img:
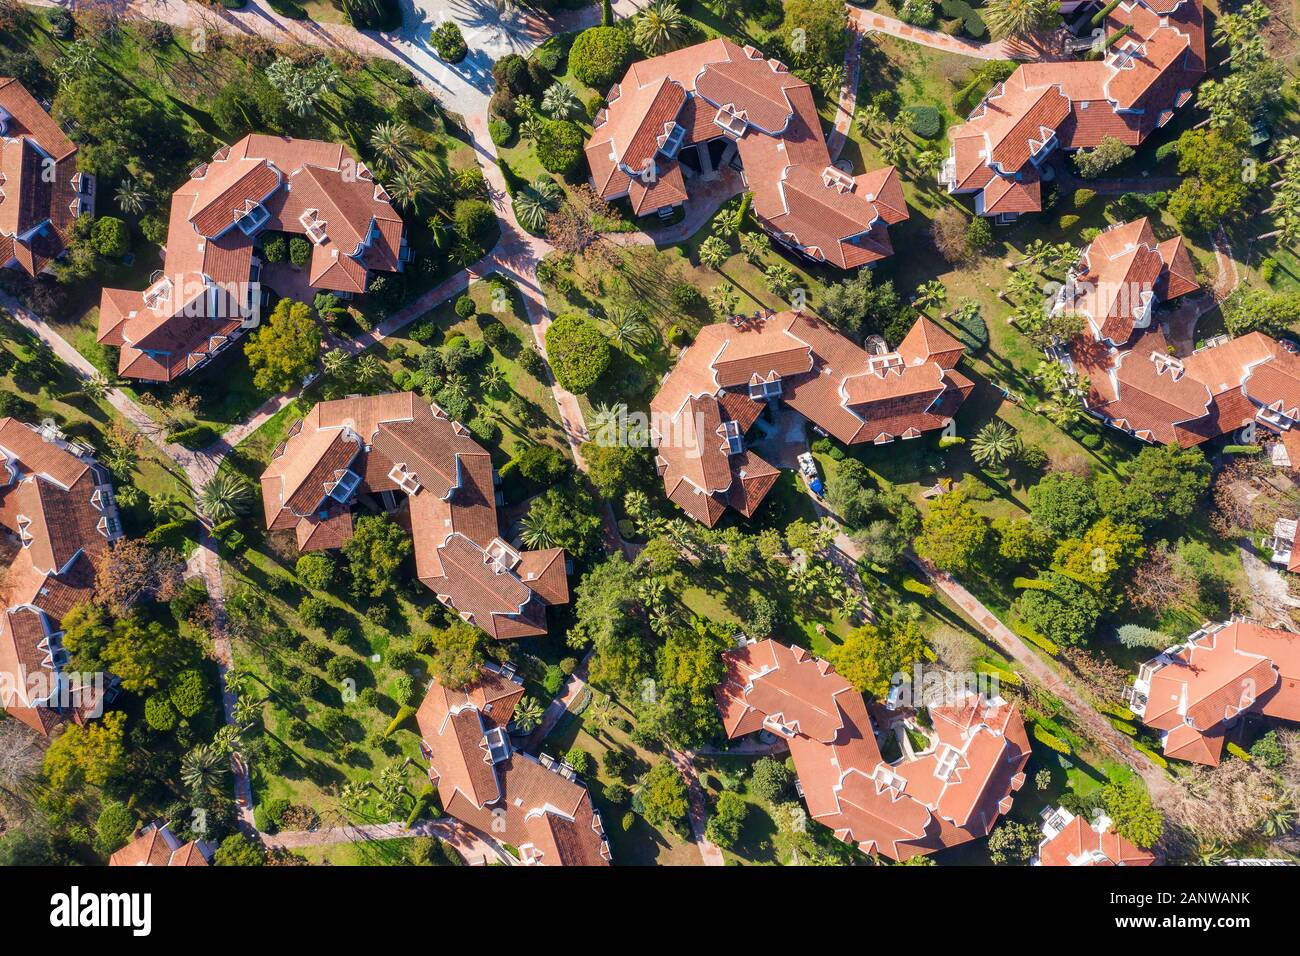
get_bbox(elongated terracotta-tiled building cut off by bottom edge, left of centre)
[415,665,611,866]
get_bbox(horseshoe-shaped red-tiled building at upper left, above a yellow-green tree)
[98,134,410,381]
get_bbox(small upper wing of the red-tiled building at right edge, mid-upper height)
[1053,217,1200,349]
